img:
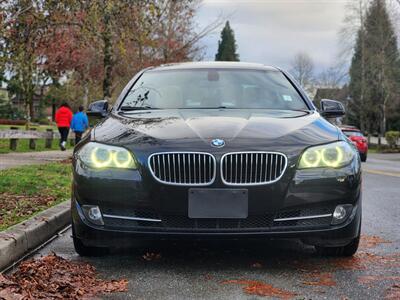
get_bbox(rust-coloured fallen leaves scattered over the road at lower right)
[217,235,400,299]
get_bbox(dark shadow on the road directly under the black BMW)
[96,240,319,272]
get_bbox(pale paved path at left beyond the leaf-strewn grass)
[0,149,72,170]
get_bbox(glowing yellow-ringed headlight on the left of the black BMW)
[77,142,137,169]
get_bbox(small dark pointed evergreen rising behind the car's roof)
[215,21,239,61]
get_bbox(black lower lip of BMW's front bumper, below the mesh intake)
[72,199,361,247]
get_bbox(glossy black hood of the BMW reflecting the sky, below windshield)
[92,109,338,150]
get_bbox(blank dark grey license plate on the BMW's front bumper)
[188,189,248,219]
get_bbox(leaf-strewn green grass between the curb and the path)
[0,163,71,231]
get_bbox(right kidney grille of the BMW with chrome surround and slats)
[220,151,288,186]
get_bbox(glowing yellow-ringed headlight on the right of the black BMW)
[299,142,355,169]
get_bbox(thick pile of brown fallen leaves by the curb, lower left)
[0,253,128,299]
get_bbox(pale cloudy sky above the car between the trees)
[197,0,354,72]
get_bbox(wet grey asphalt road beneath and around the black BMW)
[24,154,400,299]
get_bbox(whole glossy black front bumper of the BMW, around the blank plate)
[72,155,361,246]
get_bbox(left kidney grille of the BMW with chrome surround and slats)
[147,151,217,186]
